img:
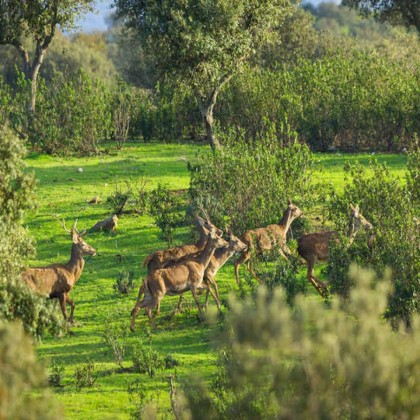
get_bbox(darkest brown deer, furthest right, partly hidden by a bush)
[297,204,373,297]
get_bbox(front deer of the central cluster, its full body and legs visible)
[130,228,228,331]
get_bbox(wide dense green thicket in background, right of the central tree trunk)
[215,52,420,151]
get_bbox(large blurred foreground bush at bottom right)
[184,270,420,419]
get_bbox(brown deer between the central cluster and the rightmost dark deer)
[235,199,303,285]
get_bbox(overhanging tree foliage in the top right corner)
[343,0,420,34]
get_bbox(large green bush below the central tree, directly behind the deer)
[189,132,313,234]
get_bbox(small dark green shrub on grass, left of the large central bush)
[150,184,184,244]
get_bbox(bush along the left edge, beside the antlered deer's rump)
[0,126,62,338]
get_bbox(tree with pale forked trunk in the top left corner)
[0,0,93,120]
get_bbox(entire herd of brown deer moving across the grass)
[22,200,372,331]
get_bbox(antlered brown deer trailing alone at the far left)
[22,220,96,323]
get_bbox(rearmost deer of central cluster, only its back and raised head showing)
[143,210,223,274]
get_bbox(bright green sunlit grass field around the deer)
[23,144,406,419]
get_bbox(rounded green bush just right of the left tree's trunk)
[31,71,111,155]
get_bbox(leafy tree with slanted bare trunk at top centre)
[115,0,295,150]
